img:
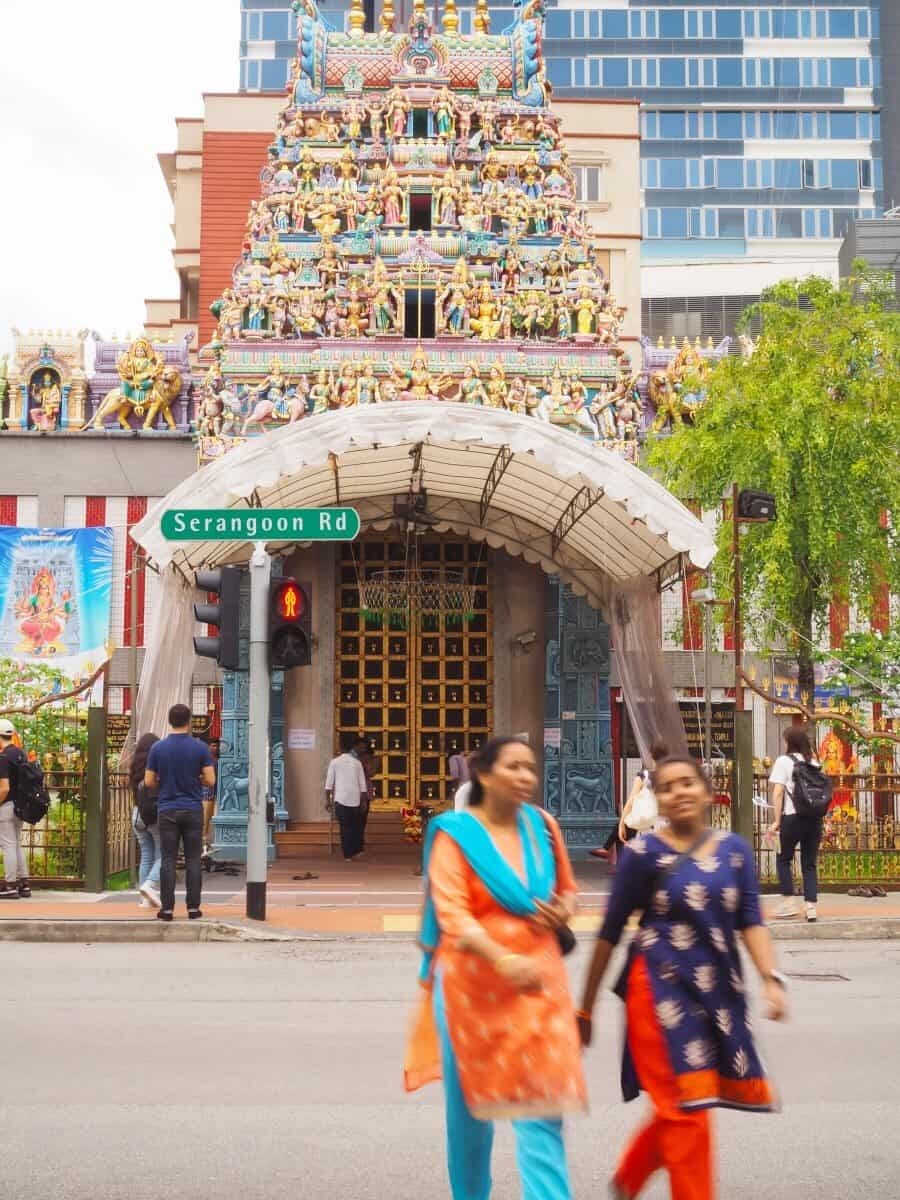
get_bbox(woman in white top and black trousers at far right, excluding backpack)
[768,725,823,922]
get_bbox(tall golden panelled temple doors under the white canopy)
[335,534,493,811]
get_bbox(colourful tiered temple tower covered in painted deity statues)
[198,0,642,461]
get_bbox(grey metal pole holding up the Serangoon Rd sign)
[247,541,271,920]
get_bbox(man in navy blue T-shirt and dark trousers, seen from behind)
[150,704,216,920]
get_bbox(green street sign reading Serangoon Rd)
[160,509,360,541]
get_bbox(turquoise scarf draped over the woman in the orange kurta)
[419,804,557,982]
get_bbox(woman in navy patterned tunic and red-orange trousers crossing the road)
[578,757,786,1200]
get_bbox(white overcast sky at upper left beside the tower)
[0,0,240,353]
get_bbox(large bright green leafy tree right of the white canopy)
[646,263,900,704]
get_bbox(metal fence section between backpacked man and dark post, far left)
[22,770,85,884]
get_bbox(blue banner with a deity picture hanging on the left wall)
[0,526,113,678]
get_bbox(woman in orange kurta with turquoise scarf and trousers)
[406,738,586,1200]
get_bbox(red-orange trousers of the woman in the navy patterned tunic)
[614,956,715,1200]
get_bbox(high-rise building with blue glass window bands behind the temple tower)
[241,0,900,338]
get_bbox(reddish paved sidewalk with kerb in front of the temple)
[0,859,900,941]
